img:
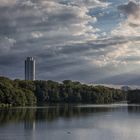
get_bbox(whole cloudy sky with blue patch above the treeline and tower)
[0,0,140,85]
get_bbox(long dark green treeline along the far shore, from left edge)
[0,77,126,106]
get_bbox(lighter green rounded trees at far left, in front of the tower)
[0,77,36,106]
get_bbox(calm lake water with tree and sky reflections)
[0,104,140,140]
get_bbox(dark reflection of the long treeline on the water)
[0,104,111,128]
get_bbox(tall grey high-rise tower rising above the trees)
[25,57,35,81]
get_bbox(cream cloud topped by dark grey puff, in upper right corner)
[111,1,140,38]
